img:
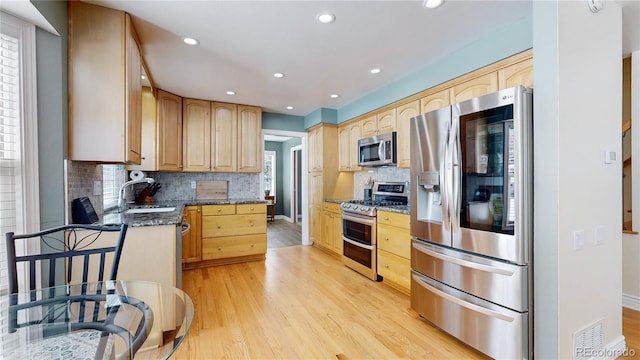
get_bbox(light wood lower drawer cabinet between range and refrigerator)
[377,210,411,294]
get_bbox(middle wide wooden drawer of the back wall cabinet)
[202,214,267,238]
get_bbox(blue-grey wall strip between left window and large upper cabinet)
[33,1,68,228]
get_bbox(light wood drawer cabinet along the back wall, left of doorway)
[183,204,267,269]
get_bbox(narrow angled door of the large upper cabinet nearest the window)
[125,15,142,164]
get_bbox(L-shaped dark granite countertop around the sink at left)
[98,199,267,227]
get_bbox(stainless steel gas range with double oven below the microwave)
[340,182,408,281]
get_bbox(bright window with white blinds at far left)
[0,13,40,294]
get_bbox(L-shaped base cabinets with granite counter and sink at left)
[94,199,266,288]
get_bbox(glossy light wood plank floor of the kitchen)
[174,246,640,359]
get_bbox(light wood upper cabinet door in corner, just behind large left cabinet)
[127,86,158,171]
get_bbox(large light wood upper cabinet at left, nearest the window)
[69,1,142,164]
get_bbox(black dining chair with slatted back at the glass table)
[6,224,153,358]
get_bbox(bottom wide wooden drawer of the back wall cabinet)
[202,234,267,260]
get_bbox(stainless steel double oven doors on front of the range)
[342,212,379,281]
